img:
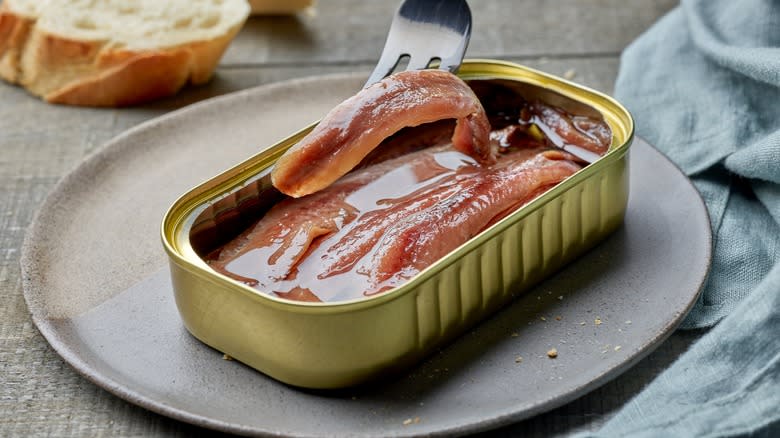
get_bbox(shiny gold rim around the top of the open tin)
[160,59,634,314]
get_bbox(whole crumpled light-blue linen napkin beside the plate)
[576,0,780,437]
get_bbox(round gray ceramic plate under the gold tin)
[22,76,711,436]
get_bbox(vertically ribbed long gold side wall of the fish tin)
[415,157,628,360]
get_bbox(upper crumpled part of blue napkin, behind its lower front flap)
[615,0,780,328]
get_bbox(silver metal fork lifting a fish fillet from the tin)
[364,0,471,88]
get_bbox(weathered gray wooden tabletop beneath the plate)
[0,0,697,436]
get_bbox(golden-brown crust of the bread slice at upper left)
[0,1,244,107]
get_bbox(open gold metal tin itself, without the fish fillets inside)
[162,60,633,388]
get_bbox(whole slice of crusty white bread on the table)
[0,0,249,106]
